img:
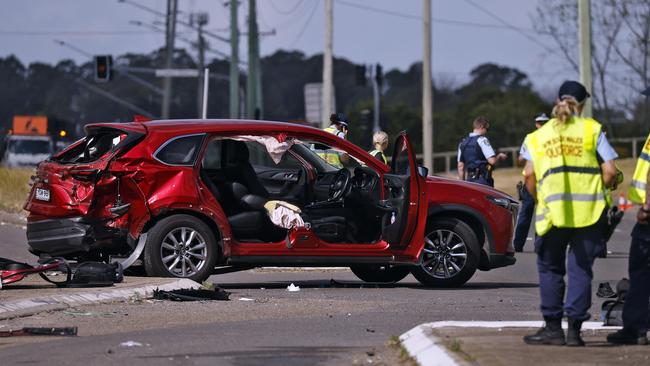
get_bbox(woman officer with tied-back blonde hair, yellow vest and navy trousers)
[524,81,618,346]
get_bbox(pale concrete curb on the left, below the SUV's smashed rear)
[0,278,201,320]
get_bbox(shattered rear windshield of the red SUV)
[52,129,140,163]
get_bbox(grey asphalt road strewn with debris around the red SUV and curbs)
[0,214,633,366]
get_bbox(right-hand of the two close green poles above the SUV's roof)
[246,0,261,118]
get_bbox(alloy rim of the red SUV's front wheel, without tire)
[421,229,467,279]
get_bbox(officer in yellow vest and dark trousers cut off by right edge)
[607,88,650,344]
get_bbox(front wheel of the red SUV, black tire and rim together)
[411,218,481,287]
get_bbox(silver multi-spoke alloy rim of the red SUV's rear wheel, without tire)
[160,226,208,277]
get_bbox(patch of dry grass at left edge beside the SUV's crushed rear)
[0,167,33,213]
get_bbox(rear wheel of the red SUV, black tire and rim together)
[144,214,219,282]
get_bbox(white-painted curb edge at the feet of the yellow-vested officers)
[399,321,621,366]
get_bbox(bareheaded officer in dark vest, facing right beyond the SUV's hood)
[458,117,507,187]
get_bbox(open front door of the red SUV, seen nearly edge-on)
[382,132,424,248]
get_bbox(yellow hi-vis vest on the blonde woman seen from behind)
[528,117,606,235]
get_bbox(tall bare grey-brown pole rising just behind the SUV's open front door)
[422,0,433,173]
